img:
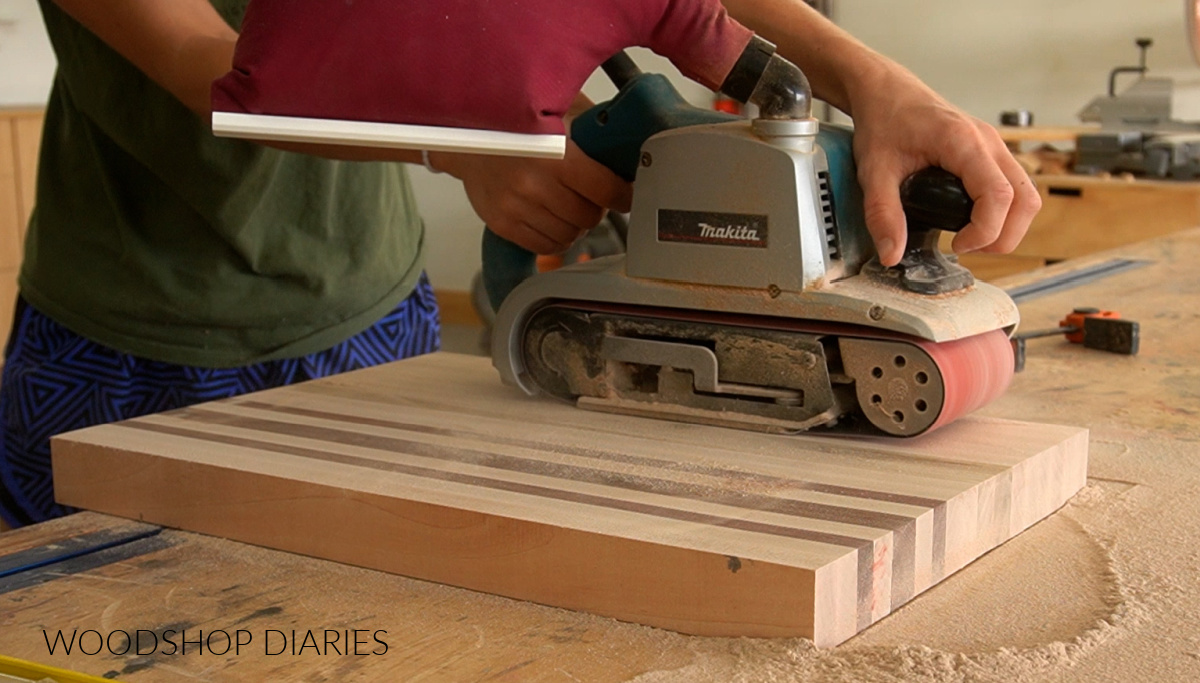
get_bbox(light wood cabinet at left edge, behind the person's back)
[0,109,42,345]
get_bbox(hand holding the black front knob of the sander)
[850,65,1042,265]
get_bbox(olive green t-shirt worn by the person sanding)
[19,0,424,367]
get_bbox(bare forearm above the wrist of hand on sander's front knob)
[721,0,898,114]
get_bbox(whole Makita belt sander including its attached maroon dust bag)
[212,0,1018,436]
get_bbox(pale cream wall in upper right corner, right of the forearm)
[836,0,1200,125]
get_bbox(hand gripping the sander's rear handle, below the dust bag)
[430,142,634,253]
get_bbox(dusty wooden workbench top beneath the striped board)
[0,230,1200,681]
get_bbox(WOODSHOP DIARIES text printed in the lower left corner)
[42,629,388,657]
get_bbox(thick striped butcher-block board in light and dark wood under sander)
[53,353,1087,646]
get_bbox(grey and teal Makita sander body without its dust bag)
[484,38,1018,436]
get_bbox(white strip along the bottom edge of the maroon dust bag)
[212,112,566,158]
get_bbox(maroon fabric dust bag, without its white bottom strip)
[212,0,752,133]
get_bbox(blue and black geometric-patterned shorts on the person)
[0,275,440,527]
